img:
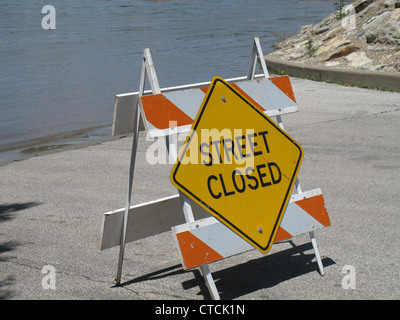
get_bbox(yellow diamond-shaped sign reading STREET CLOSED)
[170,77,303,253]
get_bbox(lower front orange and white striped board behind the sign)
[172,189,330,269]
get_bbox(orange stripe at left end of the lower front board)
[176,231,224,269]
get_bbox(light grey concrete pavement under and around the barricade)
[0,78,400,300]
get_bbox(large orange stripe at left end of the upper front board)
[142,94,193,129]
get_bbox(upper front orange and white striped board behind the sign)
[139,76,298,137]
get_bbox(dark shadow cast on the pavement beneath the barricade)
[121,241,335,300]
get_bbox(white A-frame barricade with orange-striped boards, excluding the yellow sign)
[101,37,330,299]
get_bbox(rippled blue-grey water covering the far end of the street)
[0,0,344,162]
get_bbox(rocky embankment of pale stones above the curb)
[267,0,400,72]
